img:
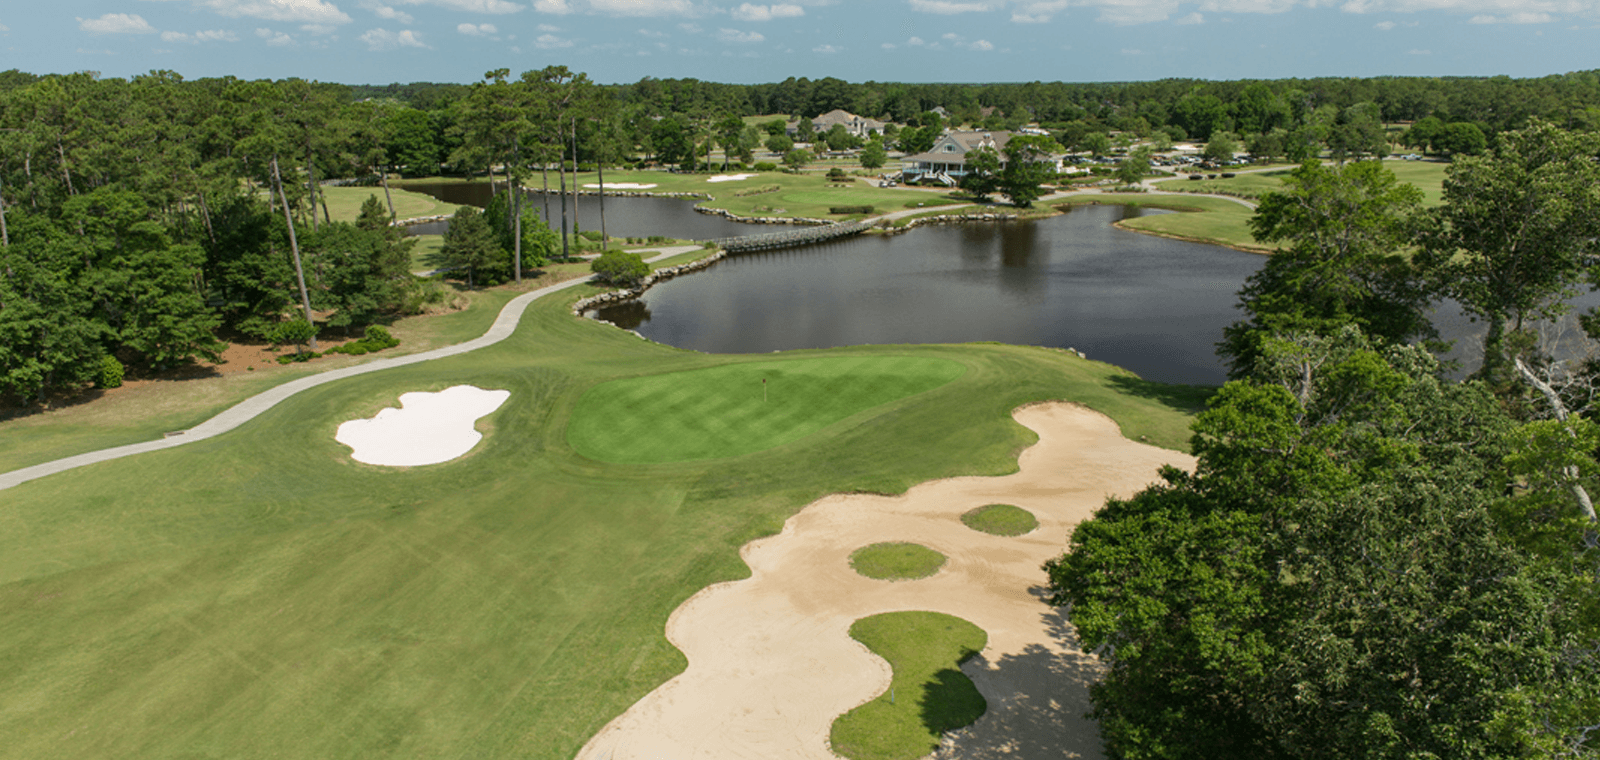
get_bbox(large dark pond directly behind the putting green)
[598,206,1266,384]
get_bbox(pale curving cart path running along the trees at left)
[0,245,699,491]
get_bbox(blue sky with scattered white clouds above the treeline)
[0,0,1600,83]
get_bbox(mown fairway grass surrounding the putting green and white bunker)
[0,265,1203,758]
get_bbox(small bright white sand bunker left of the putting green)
[334,386,510,467]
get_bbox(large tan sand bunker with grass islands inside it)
[578,403,1194,760]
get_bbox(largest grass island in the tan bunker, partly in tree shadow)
[829,613,989,760]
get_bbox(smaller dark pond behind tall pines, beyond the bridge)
[396,182,752,240]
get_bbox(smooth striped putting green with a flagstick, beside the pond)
[566,357,966,464]
